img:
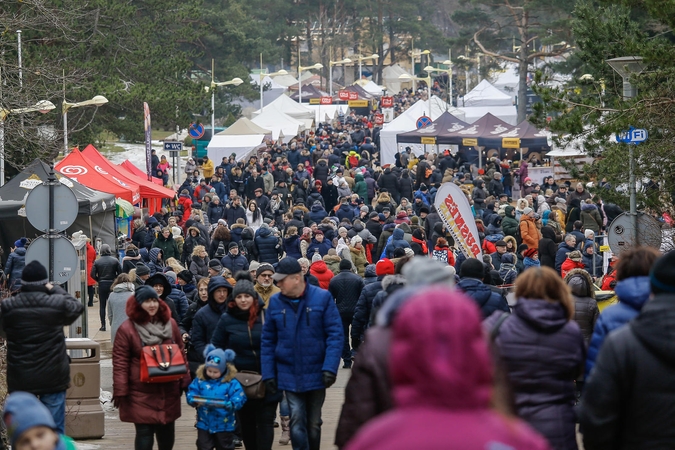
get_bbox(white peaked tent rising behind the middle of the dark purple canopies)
[458,80,518,125]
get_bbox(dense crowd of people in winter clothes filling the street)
[0,108,675,450]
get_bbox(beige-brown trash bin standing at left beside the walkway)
[66,338,105,439]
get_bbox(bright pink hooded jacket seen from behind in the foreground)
[346,287,550,450]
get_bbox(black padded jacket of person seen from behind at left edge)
[0,285,84,395]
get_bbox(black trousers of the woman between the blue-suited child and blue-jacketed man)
[237,399,277,450]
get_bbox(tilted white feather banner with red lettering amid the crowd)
[434,182,482,259]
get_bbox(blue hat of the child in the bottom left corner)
[3,391,56,447]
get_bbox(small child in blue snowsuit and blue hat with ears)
[187,344,246,450]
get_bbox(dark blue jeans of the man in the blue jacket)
[286,389,326,450]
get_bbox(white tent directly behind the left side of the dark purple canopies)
[380,95,464,165]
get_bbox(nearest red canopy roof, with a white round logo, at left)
[54,149,141,204]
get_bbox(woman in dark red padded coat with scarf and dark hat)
[113,286,190,450]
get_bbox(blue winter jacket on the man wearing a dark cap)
[261,285,344,393]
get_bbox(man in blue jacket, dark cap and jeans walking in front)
[261,257,343,450]
